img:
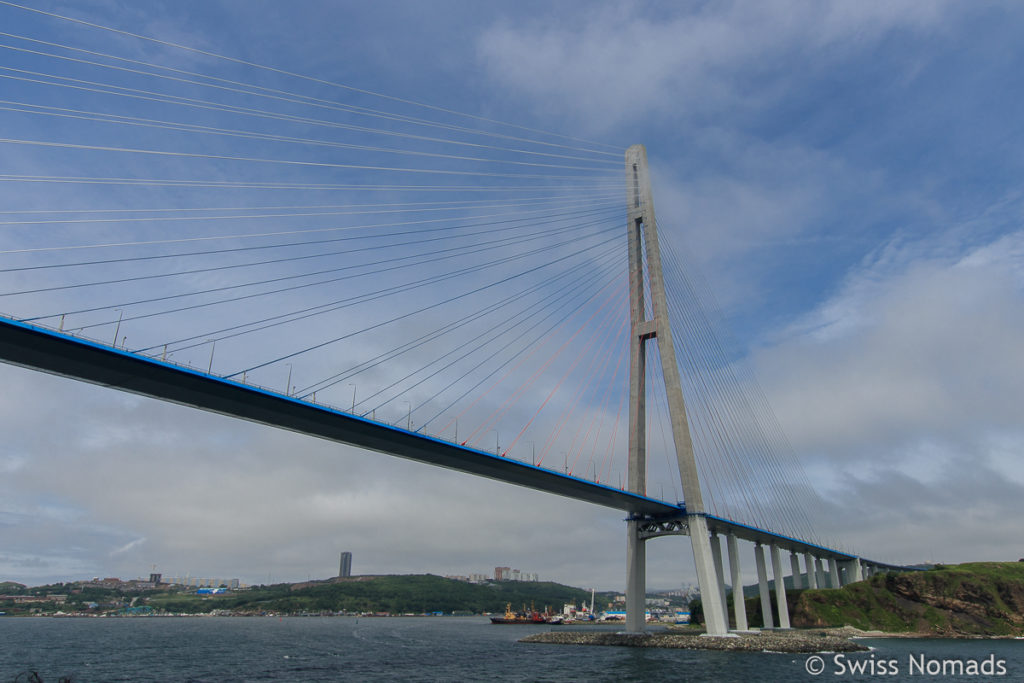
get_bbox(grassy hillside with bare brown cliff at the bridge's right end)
[792,562,1024,636]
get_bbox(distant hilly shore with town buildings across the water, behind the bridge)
[0,552,696,620]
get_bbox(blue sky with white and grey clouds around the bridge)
[0,0,1024,590]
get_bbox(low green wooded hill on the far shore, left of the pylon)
[147,574,610,614]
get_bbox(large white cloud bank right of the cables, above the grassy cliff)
[755,228,1024,561]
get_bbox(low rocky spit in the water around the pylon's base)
[519,629,869,653]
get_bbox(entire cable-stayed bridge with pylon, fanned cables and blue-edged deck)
[0,3,913,634]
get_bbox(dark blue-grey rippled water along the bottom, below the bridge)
[0,617,1024,683]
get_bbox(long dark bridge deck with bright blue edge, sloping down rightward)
[0,317,898,568]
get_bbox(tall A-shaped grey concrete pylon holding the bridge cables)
[626,144,729,636]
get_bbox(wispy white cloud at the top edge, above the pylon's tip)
[477,2,949,134]
